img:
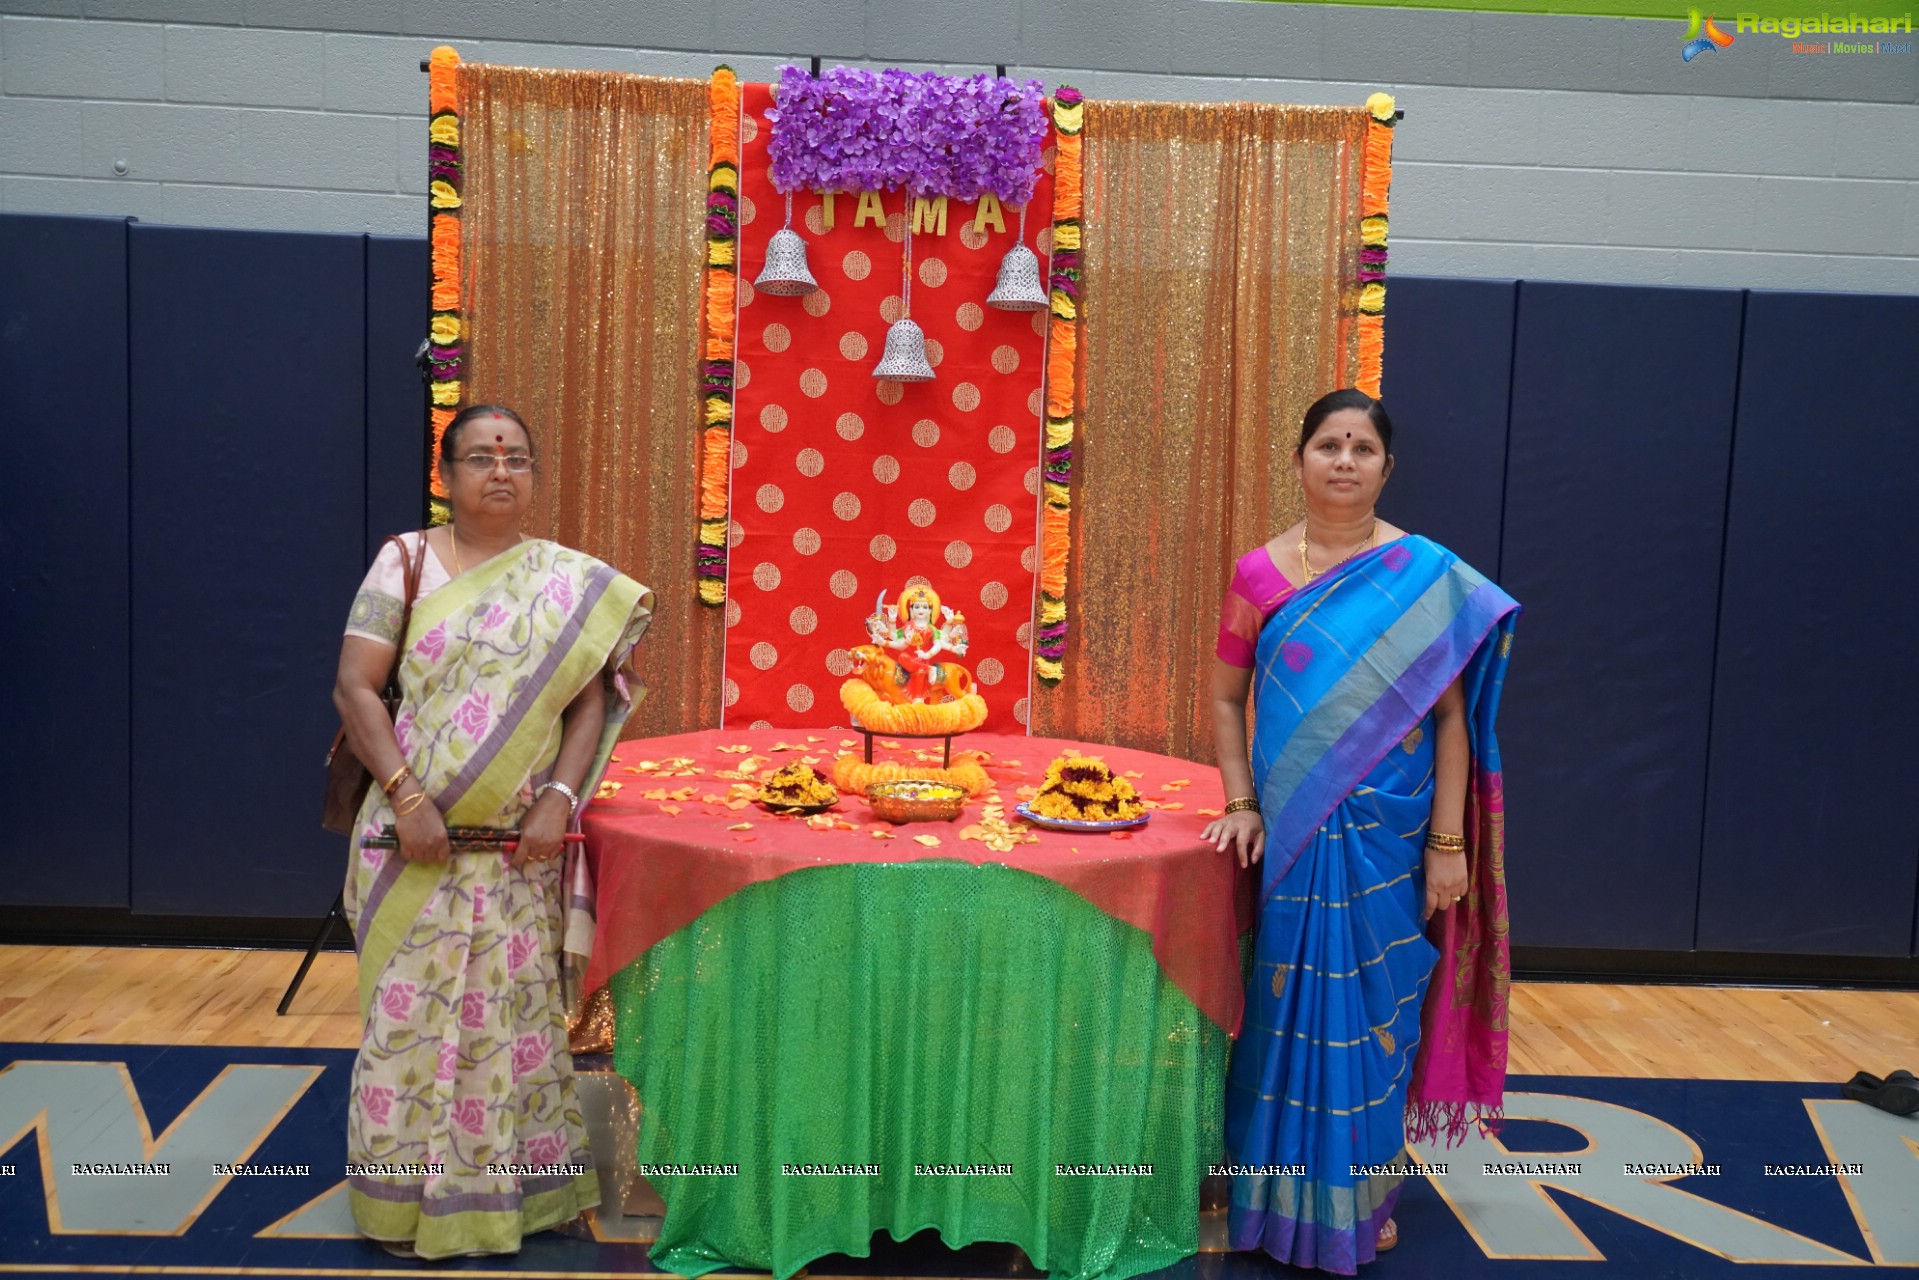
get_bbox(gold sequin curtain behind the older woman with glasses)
[459,63,725,737]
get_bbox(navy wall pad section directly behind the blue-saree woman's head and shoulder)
[1380,278,1520,581]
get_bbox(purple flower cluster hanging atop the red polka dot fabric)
[766,67,1046,207]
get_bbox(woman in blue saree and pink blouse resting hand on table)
[1205,390,1518,1274]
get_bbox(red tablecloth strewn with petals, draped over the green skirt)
[583,729,1257,1034]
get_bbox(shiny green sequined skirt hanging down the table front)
[612,862,1228,1280]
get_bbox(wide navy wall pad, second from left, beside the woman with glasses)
[129,226,367,917]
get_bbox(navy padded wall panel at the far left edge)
[0,213,129,908]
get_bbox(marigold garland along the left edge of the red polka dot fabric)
[693,65,741,604]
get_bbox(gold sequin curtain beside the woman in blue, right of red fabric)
[1032,100,1366,762]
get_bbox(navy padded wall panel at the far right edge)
[1698,294,1919,956]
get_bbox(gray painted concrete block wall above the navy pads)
[0,0,1919,292]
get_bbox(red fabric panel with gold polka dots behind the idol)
[723,84,1054,733]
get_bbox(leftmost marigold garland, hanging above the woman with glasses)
[426,44,466,524]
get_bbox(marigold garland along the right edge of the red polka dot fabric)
[1032,84,1086,685]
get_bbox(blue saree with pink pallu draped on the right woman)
[1226,537,1518,1274]
